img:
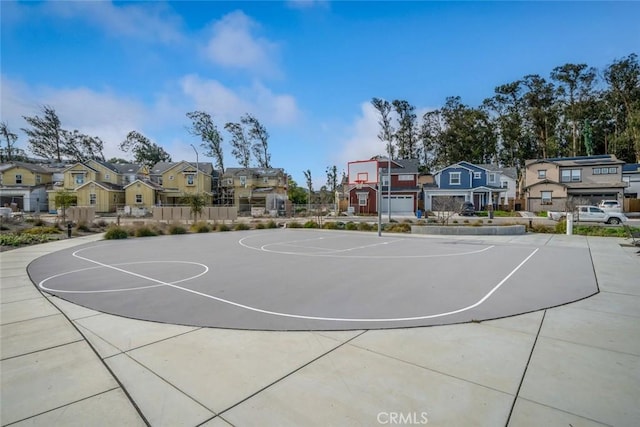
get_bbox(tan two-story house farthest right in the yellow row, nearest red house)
[220,168,288,215]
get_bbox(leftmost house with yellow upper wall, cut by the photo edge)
[0,161,59,212]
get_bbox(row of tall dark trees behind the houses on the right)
[371,53,640,171]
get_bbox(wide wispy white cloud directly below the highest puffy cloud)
[180,74,300,126]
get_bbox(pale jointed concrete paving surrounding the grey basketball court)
[0,234,640,426]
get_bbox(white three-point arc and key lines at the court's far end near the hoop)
[238,235,495,259]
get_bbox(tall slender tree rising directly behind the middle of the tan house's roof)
[551,64,596,156]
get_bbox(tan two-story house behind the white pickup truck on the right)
[523,154,627,212]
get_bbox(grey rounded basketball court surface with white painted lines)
[28,229,598,330]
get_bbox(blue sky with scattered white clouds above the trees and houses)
[0,1,640,189]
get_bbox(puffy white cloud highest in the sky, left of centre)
[204,10,278,75]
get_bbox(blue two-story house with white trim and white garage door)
[424,162,516,211]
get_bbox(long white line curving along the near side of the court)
[38,242,540,322]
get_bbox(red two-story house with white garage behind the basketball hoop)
[348,157,420,215]
